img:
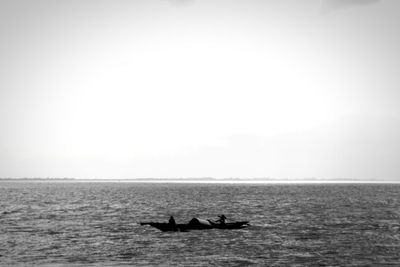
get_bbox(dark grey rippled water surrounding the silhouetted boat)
[0,182,400,266]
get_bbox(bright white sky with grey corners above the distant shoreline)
[0,0,400,180]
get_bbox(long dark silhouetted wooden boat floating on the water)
[140,218,249,232]
